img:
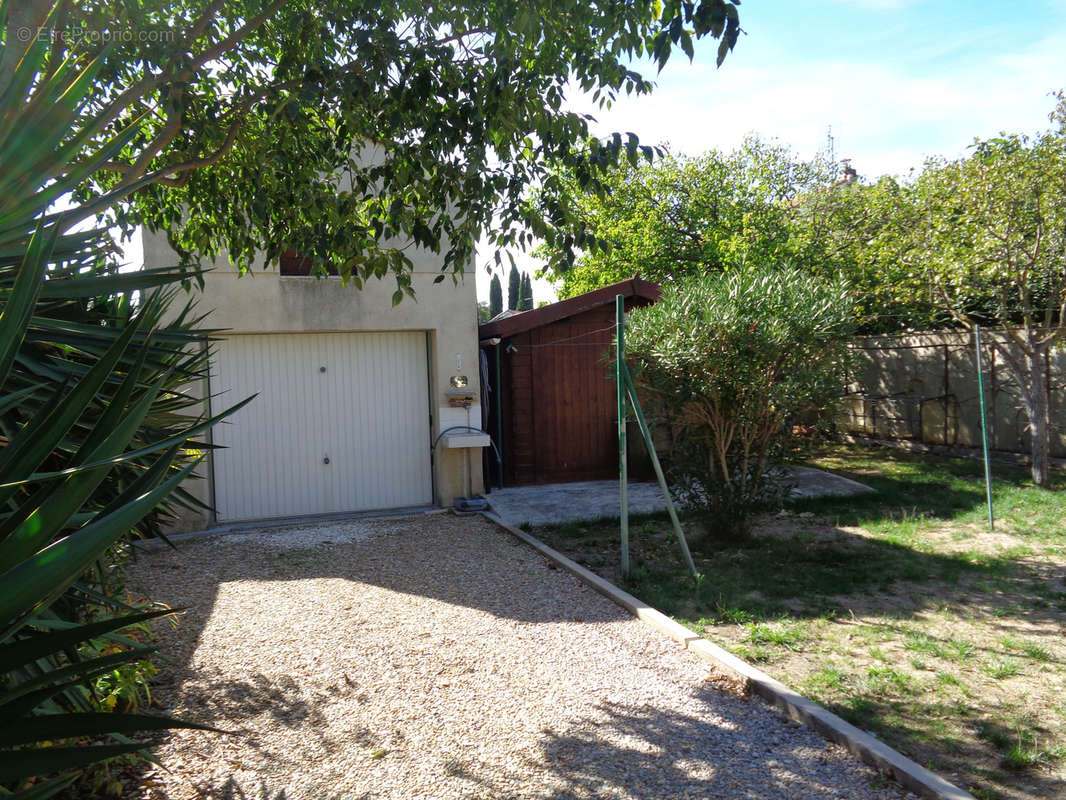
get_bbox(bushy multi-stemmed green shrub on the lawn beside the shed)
[626,269,854,539]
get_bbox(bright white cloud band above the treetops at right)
[579,30,1066,174]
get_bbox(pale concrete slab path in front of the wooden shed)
[488,466,874,526]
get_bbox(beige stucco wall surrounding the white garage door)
[143,231,484,530]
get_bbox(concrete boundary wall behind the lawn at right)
[838,330,1066,458]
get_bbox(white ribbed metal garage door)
[211,332,433,521]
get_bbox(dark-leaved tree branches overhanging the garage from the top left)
[0,0,740,300]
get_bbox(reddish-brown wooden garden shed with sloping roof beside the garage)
[479,278,660,486]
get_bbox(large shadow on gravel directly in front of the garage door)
[131,515,630,626]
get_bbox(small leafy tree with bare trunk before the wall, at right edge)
[900,96,1066,486]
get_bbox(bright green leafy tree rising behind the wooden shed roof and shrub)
[539,137,834,297]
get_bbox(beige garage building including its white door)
[144,231,487,530]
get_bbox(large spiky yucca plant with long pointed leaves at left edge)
[0,12,245,800]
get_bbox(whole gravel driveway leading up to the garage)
[130,514,909,800]
